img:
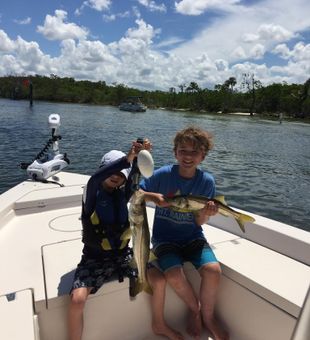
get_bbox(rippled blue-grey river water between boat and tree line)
[0,99,310,231]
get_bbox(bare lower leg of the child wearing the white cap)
[68,287,92,340]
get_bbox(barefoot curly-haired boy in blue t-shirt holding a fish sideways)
[140,127,228,340]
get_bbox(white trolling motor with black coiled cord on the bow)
[20,114,70,182]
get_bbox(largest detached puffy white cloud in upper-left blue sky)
[37,9,88,40]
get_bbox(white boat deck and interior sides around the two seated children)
[0,172,310,340]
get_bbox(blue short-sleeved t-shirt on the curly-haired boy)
[140,165,215,244]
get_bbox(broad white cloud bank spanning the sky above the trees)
[0,0,310,90]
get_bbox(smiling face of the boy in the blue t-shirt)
[175,142,206,169]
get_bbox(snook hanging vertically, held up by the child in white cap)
[129,190,152,297]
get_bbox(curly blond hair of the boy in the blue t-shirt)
[173,126,213,154]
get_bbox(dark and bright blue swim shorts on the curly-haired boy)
[148,238,218,272]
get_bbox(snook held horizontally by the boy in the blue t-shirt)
[165,195,255,232]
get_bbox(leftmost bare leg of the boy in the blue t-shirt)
[147,267,184,340]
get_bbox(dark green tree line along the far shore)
[0,74,310,119]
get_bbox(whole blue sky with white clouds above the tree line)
[0,0,310,91]
